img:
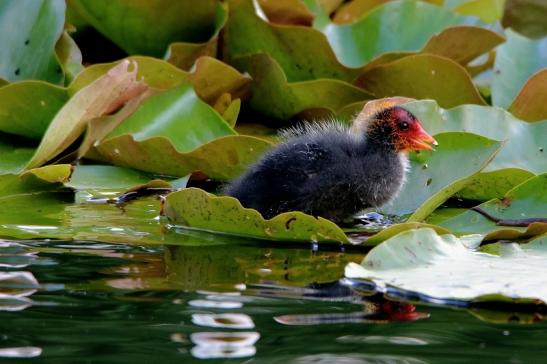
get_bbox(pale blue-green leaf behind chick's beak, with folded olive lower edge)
[405,101,547,200]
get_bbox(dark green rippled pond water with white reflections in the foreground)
[0,200,547,364]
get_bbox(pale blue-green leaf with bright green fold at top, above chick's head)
[322,0,479,67]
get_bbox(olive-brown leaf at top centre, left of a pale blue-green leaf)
[223,0,359,82]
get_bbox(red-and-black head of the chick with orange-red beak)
[352,98,437,152]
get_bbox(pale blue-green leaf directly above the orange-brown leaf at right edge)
[492,29,547,108]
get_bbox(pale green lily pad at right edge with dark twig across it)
[441,173,547,239]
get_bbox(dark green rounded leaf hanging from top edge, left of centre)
[69,0,217,57]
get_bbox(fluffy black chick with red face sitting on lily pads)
[223,98,437,224]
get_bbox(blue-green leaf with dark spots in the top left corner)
[0,0,65,83]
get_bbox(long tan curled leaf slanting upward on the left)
[26,61,146,169]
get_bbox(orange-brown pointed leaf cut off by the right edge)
[508,69,547,121]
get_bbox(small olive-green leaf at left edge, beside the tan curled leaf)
[0,81,69,139]
